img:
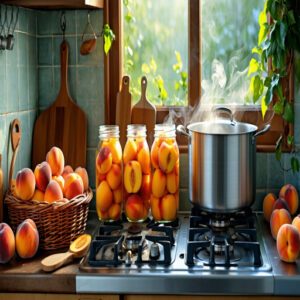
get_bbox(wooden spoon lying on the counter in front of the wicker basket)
[41,234,92,272]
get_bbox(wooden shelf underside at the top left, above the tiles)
[1,0,105,9]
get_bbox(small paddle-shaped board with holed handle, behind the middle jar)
[131,76,156,147]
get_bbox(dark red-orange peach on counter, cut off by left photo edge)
[0,223,15,264]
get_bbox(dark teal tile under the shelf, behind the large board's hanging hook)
[37,10,76,35]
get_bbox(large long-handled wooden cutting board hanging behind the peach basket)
[32,41,87,168]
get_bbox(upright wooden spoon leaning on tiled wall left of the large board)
[8,119,22,189]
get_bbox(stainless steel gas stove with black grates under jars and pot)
[76,210,273,294]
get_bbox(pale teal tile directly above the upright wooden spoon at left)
[5,66,19,112]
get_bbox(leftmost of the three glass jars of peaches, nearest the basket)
[96,125,123,221]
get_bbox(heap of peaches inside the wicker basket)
[12,147,89,203]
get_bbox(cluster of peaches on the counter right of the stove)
[263,184,300,262]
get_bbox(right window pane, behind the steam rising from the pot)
[201,0,264,104]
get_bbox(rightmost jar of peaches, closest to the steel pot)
[150,124,179,222]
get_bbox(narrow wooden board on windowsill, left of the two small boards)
[116,76,131,148]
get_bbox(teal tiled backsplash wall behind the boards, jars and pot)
[0,5,300,210]
